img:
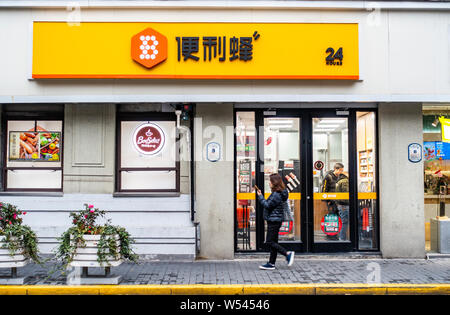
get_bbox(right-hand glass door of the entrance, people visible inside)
[309,114,353,252]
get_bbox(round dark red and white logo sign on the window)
[133,123,166,155]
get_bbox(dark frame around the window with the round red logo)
[114,112,181,193]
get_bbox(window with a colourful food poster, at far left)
[3,119,63,191]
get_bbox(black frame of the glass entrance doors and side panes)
[233,107,380,253]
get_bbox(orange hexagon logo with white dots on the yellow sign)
[131,27,167,69]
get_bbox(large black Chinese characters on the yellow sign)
[176,31,260,62]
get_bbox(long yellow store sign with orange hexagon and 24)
[32,22,359,80]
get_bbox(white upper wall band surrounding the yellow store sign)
[0,8,450,103]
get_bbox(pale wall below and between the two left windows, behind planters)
[0,104,196,260]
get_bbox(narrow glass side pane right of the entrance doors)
[356,112,378,250]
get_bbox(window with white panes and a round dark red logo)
[117,115,180,192]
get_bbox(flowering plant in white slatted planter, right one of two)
[56,204,138,283]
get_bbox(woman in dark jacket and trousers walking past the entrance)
[256,173,295,270]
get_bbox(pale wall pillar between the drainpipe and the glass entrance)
[194,104,234,259]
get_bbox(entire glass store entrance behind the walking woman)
[235,109,379,252]
